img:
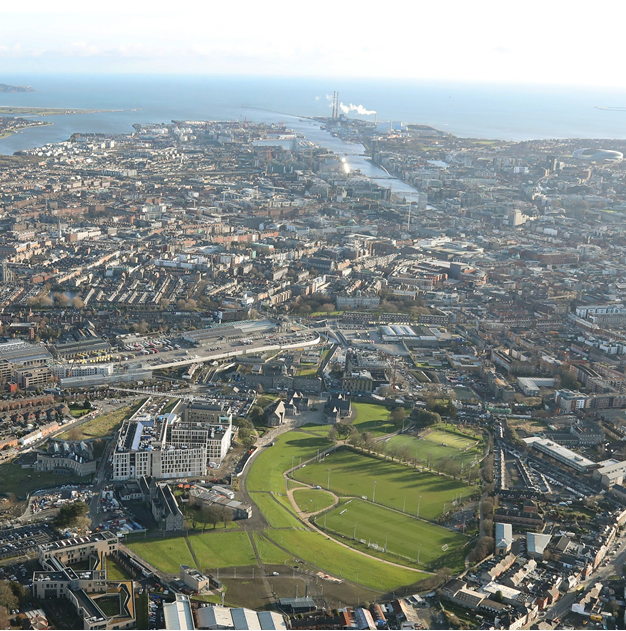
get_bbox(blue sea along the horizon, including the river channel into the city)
[0,74,626,196]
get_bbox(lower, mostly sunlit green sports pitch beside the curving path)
[316,500,467,569]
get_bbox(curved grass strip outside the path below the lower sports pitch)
[265,530,425,592]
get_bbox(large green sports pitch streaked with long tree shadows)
[294,449,474,519]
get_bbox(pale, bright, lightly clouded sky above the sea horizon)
[0,0,626,89]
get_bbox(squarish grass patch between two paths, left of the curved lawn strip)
[189,532,256,570]
